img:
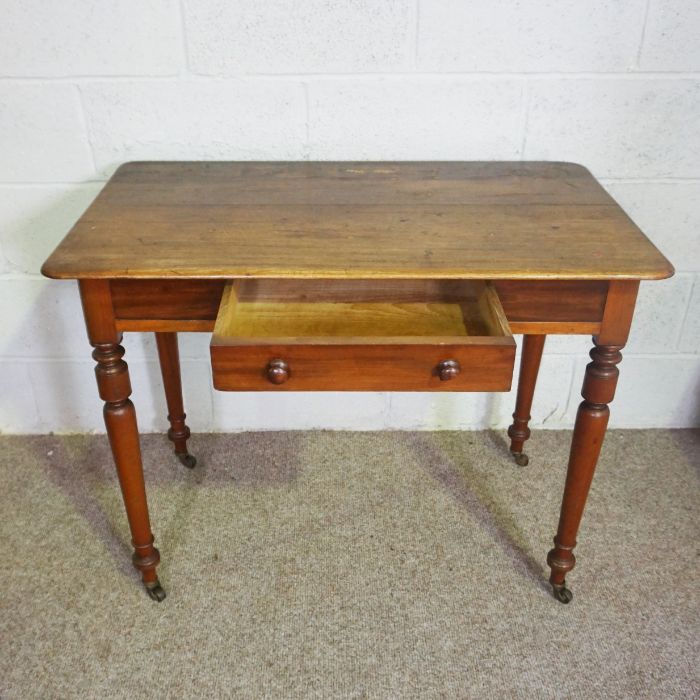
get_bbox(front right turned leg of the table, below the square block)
[547,339,623,603]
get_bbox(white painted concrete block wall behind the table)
[0,0,700,432]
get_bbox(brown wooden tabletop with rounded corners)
[42,161,673,279]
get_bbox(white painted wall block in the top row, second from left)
[184,0,415,76]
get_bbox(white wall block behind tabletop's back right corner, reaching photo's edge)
[523,77,700,179]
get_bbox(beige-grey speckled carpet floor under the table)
[0,431,700,700]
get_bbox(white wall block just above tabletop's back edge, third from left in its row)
[309,76,523,160]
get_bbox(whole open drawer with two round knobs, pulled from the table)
[211,280,515,391]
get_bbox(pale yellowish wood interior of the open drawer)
[212,280,514,345]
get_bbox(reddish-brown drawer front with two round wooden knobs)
[211,342,515,391]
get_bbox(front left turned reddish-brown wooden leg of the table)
[80,280,160,590]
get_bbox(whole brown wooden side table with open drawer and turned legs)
[42,162,673,603]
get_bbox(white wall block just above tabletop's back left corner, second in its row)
[81,78,306,177]
